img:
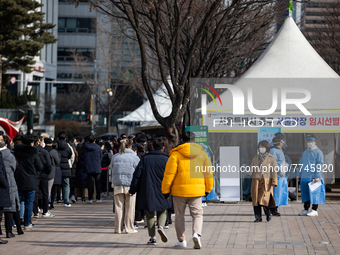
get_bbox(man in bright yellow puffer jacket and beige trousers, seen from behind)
[162,132,214,249]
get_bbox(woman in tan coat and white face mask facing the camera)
[247,141,277,222]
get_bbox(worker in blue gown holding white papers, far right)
[297,135,325,216]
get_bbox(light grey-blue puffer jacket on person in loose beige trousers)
[110,149,139,186]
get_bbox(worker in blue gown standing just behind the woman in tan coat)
[269,133,288,216]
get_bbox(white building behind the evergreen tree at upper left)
[6,0,58,124]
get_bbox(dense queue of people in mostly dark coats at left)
[0,131,117,244]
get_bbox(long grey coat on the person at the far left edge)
[1,148,20,212]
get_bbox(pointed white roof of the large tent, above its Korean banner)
[207,17,340,111]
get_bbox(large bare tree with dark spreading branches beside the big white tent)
[70,0,288,142]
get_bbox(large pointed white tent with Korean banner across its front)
[202,17,340,200]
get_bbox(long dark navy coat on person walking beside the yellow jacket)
[130,150,169,211]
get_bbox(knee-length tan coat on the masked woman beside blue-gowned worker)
[250,154,277,208]
